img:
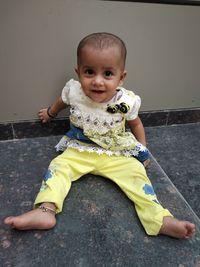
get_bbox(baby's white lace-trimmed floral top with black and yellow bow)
[56,79,144,156]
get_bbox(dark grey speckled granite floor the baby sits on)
[0,124,200,267]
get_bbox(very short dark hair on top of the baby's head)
[77,32,127,67]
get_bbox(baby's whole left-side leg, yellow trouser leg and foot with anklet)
[4,149,96,230]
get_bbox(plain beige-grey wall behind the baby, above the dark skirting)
[0,0,200,122]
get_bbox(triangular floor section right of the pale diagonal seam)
[146,123,200,218]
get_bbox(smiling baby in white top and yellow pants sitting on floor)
[4,33,195,238]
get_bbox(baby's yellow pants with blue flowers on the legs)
[35,148,172,235]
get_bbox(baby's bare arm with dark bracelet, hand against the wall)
[38,97,67,123]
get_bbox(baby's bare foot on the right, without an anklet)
[159,216,195,238]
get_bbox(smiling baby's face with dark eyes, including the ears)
[76,45,126,103]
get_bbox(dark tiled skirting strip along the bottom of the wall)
[0,108,200,140]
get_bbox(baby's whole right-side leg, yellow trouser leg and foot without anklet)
[99,156,195,238]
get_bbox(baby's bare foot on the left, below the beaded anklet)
[4,208,56,230]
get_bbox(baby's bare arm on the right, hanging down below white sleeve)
[128,117,146,146]
